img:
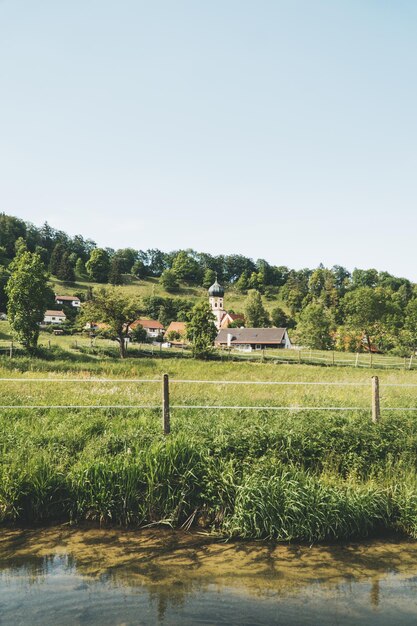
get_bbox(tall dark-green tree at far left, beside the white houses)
[5,247,54,353]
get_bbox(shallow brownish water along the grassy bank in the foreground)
[0,526,417,626]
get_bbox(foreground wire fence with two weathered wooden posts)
[0,374,417,434]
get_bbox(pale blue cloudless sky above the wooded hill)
[0,0,417,281]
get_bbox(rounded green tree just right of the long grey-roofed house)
[297,302,333,350]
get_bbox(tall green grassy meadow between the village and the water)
[0,346,417,542]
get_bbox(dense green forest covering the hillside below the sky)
[0,213,417,354]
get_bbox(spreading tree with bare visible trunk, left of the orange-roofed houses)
[81,287,140,359]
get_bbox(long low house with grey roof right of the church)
[214,328,291,352]
